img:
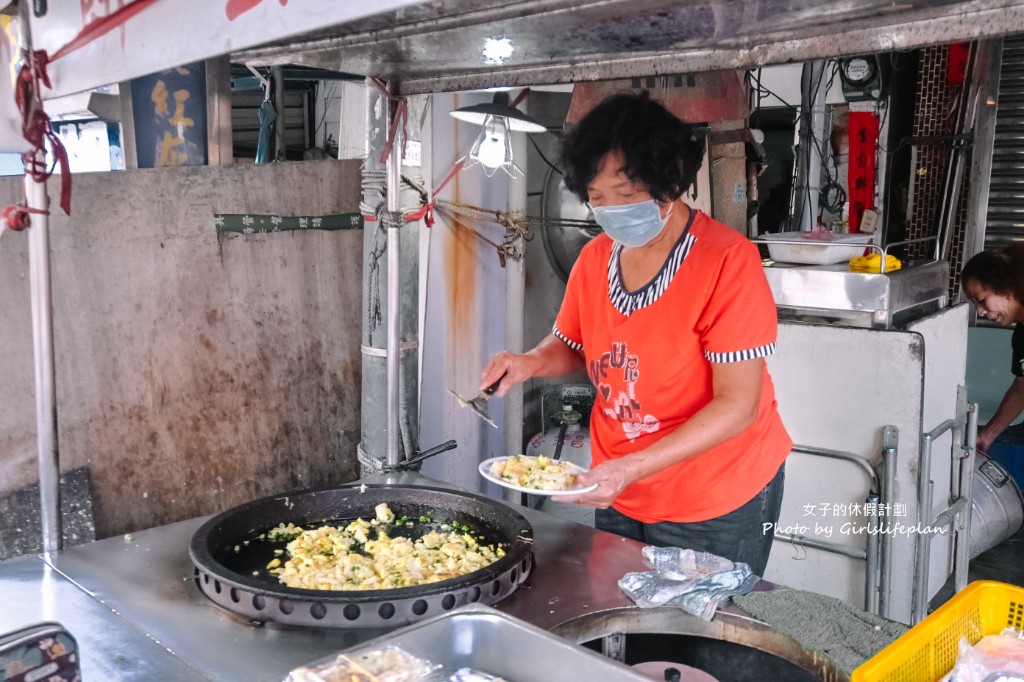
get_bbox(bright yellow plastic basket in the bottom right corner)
[853,581,1024,682]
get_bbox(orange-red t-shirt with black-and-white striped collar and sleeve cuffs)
[553,210,793,523]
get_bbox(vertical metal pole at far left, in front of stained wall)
[25,159,63,553]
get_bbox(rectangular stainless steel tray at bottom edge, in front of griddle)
[288,604,650,682]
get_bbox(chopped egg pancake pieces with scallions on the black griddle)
[267,504,505,590]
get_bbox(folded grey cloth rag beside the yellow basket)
[733,588,907,673]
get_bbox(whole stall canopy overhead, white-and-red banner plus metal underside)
[32,0,1024,97]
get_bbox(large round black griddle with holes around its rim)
[189,484,534,628]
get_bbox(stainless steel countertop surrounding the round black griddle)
[0,474,648,682]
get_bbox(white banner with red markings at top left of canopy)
[31,0,422,99]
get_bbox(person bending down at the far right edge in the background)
[961,244,1024,453]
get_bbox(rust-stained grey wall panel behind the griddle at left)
[0,161,362,538]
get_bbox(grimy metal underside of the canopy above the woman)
[234,0,1024,94]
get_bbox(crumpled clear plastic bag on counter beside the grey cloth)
[618,546,758,621]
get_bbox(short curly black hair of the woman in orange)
[560,90,705,202]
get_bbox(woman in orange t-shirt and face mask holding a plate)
[481,93,793,576]
